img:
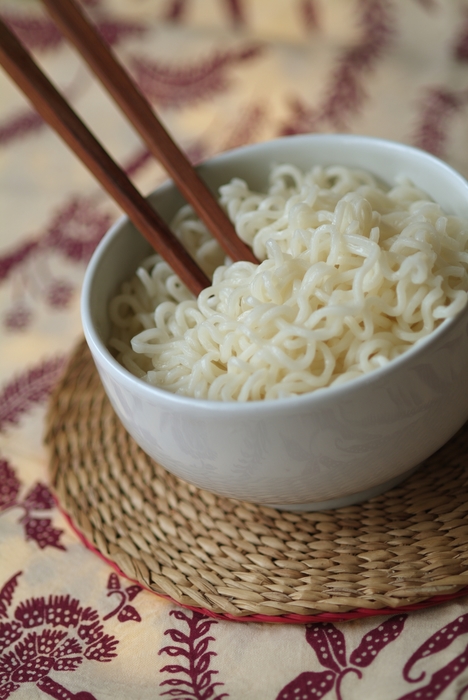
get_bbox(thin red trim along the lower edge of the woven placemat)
[54,495,468,625]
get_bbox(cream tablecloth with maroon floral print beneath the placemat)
[0,0,468,700]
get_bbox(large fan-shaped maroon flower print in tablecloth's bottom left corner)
[0,572,118,700]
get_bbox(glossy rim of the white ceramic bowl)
[80,134,468,414]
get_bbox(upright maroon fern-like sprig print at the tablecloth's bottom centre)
[159,610,228,700]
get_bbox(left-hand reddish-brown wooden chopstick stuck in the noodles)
[0,20,211,295]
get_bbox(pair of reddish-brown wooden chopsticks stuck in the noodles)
[0,0,258,295]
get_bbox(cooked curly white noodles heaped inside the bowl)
[109,165,468,401]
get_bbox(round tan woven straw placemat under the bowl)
[46,341,468,622]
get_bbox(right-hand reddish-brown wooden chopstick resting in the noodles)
[43,0,258,263]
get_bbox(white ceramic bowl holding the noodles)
[82,135,468,510]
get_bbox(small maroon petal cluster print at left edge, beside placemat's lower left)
[0,458,65,549]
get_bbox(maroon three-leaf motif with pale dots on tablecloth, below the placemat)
[276,615,408,700]
